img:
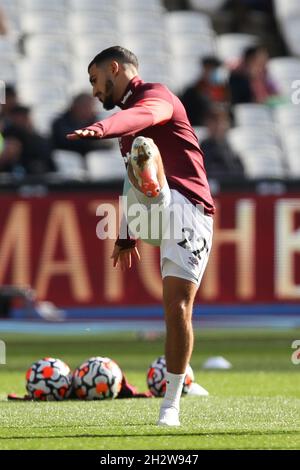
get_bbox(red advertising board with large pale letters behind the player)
[0,192,300,307]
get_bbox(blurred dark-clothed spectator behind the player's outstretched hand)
[52,93,111,156]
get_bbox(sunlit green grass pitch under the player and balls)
[0,330,300,450]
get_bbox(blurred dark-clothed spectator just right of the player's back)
[200,105,244,179]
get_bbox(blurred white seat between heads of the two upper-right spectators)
[217,33,258,65]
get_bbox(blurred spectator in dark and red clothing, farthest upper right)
[229,45,278,105]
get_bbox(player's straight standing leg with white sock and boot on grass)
[158,276,198,426]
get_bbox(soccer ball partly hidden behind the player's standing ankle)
[147,356,195,397]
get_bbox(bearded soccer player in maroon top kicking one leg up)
[67,46,215,426]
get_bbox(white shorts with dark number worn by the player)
[124,177,213,286]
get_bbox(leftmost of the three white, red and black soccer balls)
[26,357,72,401]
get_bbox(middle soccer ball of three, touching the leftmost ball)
[73,357,123,400]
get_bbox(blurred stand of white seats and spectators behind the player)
[0,0,300,184]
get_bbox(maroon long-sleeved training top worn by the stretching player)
[86,76,215,214]
